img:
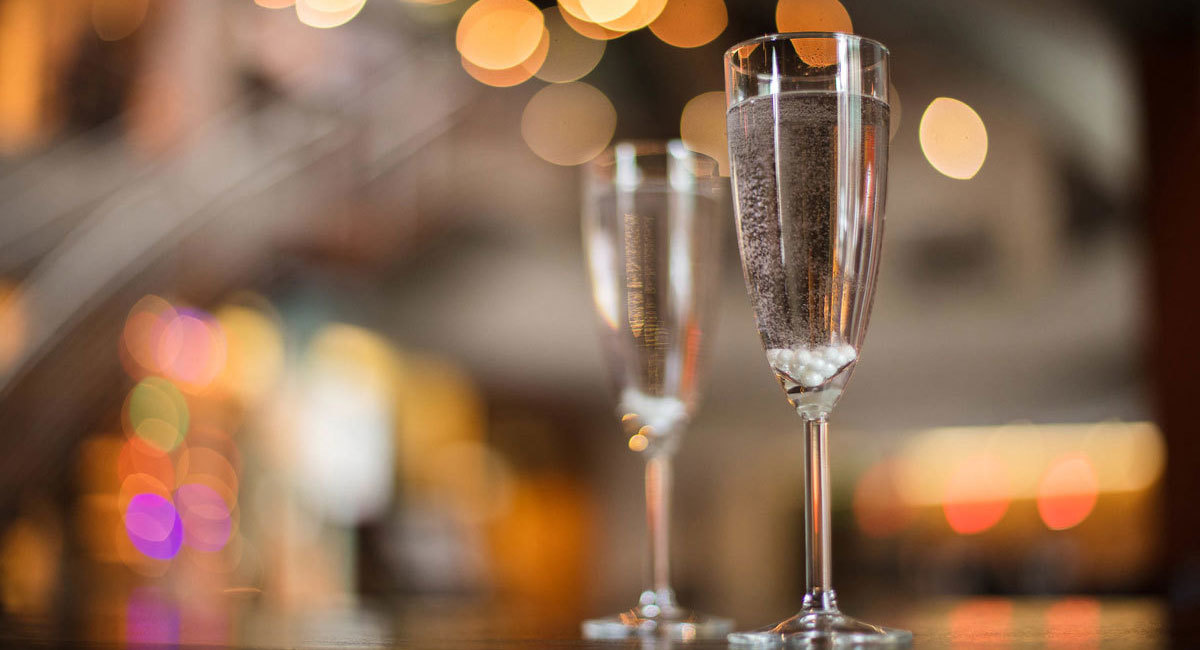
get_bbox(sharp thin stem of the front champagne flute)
[804,417,838,610]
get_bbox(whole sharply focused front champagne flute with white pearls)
[725,32,912,648]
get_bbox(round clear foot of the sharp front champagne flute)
[728,609,912,648]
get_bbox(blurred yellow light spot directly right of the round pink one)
[216,305,283,402]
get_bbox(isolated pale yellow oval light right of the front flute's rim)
[920,97,988,180]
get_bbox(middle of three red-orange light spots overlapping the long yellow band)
[942,455,1012,535]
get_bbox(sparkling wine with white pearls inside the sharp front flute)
[727,91,888,417]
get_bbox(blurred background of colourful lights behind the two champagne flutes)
[0,0,1200,644]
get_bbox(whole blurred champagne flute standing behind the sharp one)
[583,140,732,640]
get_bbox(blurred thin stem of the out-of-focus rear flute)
[642,452,676,615]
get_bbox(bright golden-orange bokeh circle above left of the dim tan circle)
[455,0,546,70]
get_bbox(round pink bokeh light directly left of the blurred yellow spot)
[157,309,226,392]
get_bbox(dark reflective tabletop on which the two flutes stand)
[0,596,1171,650]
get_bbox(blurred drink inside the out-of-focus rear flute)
[584,187,722,434]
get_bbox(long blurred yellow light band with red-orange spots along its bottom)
[853,422,1165,537]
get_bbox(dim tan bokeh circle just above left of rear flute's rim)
[521,82,617,165]
